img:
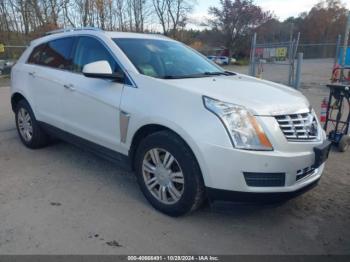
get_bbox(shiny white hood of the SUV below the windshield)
[164,75,310,115]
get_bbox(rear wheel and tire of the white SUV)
[15,100,49,149]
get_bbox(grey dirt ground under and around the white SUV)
[0,61,350,254]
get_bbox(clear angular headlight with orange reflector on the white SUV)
[203,96,273,150]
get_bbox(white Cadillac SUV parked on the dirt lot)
[11,29,330,216]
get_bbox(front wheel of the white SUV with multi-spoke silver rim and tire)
[134,131,205,217]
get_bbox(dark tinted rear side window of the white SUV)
[28,37,74,70]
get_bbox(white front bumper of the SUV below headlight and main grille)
[200,117,325,195]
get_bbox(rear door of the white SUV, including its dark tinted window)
[28,37,74,128]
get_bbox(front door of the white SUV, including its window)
[62,36,124,151]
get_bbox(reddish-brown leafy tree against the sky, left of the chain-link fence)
[209,0,272,51]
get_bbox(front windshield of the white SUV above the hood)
[113,38,228,79]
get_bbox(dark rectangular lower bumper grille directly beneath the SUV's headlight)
[243,172,286,187]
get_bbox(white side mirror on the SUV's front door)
[83,60,124,82]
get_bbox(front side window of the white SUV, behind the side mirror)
[73,36,122,73]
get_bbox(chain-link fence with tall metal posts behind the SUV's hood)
[249,35,341,88]
